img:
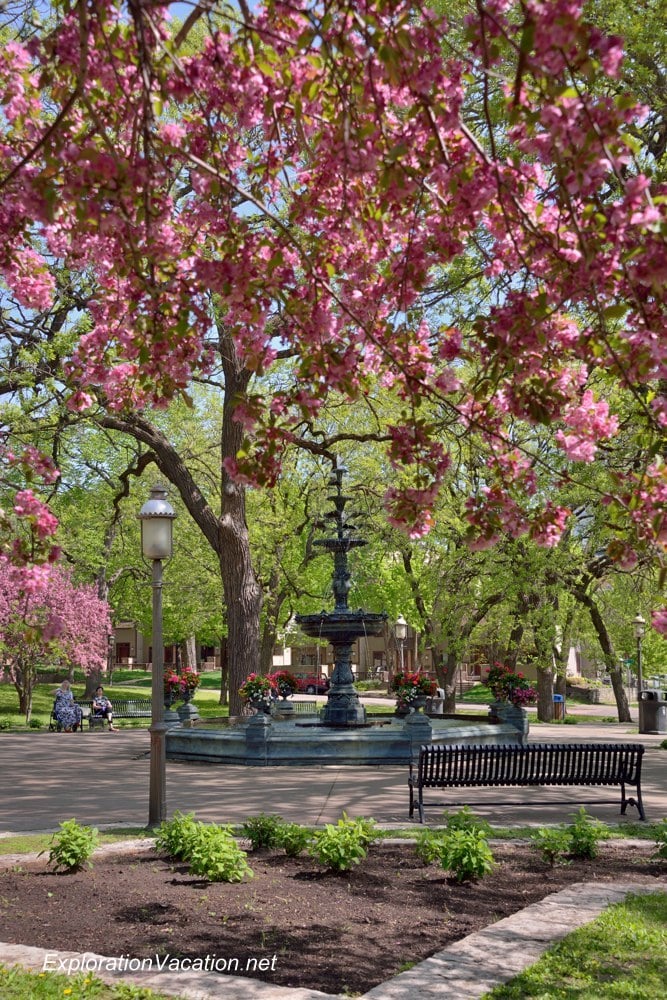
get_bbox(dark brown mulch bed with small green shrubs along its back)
[0,842,667,993]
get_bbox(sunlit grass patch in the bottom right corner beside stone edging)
[485,892,667,1000]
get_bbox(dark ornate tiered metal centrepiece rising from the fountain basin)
[296,462,387,726]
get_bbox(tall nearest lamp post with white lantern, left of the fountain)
[138,485,176,828]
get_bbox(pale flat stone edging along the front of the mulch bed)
[0,882,665,1000]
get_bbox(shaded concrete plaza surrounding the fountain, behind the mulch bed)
[0,723,667,833]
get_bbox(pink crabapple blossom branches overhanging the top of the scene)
[0,0,667,712]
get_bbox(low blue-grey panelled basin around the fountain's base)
[166,715,524,767]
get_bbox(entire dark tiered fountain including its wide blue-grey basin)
[166,462,523,767]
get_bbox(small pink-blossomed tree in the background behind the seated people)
[0,564,111,722]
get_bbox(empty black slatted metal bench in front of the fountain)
[408,743,646,823]
